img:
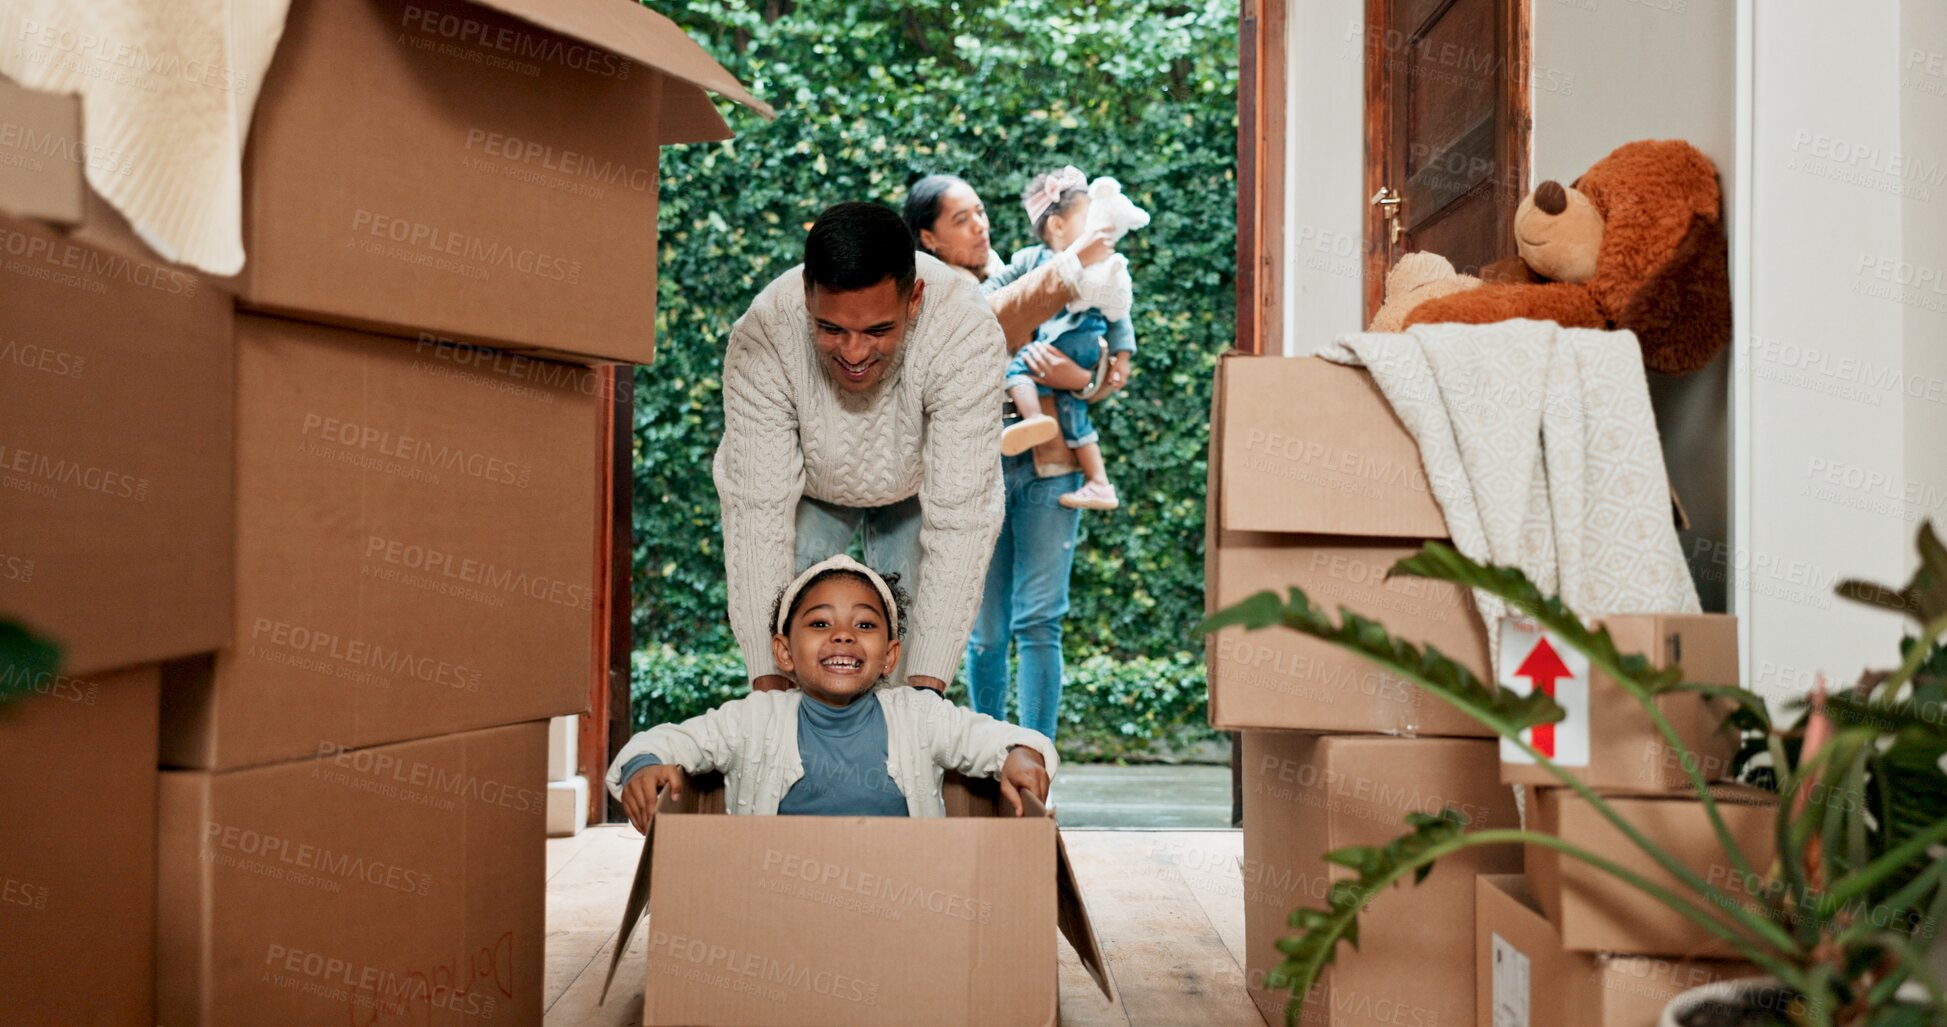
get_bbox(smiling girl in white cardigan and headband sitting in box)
[607,555,1057,830]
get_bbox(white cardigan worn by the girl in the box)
[607,686,1059,817]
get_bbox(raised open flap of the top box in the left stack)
[473,0,777,142]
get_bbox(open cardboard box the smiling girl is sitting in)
[604,774,1116,1027]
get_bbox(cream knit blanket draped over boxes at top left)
[0,0,290,275]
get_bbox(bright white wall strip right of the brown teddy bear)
[1744,0,1908,700]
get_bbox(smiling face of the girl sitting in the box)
[771,575,900,705]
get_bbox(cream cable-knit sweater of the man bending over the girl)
[715,253,1007,680]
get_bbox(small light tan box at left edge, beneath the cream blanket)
[0,78,85,224]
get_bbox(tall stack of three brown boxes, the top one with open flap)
[135,0,759,1023]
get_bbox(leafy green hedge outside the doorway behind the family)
[635,0,1236,697]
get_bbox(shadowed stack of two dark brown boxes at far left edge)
[0,190,232,1023]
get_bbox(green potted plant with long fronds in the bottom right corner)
[1199,524,1947,1027]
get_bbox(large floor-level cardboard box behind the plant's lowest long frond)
[1242,731,1521,1027]
